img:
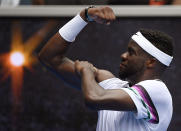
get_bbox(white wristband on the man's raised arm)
[59,14,87,42]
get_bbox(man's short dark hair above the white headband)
[140,29,173,56]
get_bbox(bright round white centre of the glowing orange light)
[10,52,25,66]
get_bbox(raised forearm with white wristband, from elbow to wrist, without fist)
[40,10,87,63]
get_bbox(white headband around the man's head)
[131,32,173,66]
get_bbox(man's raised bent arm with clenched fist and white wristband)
[39,7,115,88]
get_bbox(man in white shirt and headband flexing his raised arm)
[39,7,173,131]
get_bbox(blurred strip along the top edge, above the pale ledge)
[0,0,181,6]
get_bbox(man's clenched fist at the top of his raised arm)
[80,6,116,25]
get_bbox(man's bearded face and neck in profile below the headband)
[119,40,161,85]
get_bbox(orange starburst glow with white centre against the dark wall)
[0,21,58,106]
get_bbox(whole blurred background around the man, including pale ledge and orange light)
[0,0,181,131]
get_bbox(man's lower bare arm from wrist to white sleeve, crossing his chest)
[81,69,136,111]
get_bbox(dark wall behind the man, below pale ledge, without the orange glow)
[0,17,181,131]
